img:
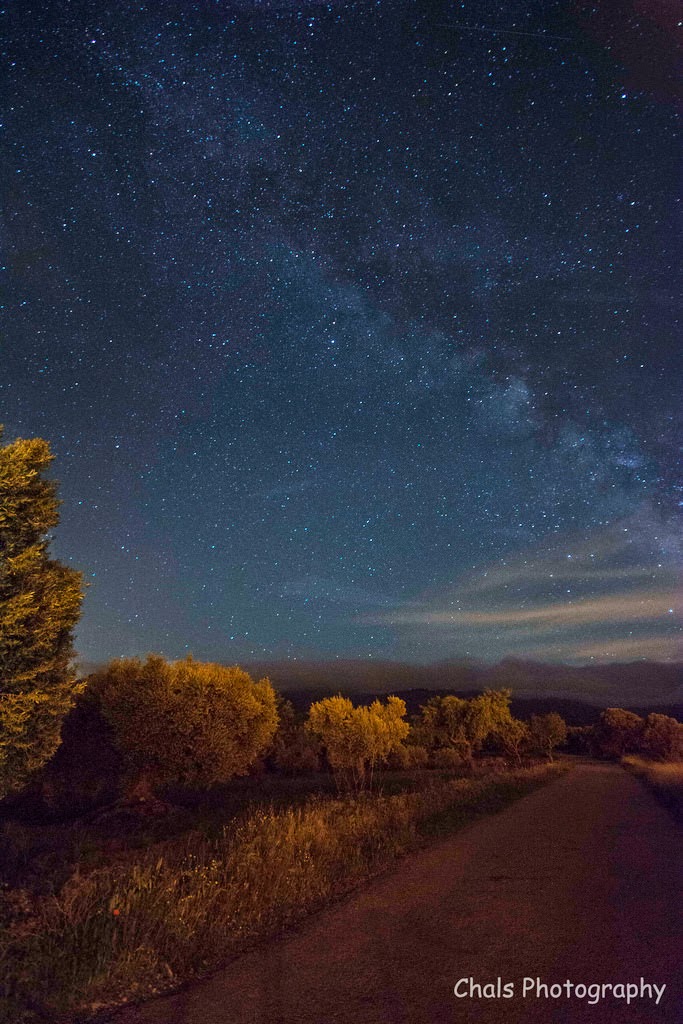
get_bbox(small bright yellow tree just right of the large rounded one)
[306,695,410,792]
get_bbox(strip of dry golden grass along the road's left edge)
[0,765,565,1024]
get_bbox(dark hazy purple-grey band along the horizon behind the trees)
[245,658,683,720]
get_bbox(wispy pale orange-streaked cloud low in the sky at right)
[361,513,682,662]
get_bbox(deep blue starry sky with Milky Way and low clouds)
[0,0,683,664]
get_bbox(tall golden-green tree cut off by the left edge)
[0,433,83,797]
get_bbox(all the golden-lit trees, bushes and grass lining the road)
[0,428,683,1024]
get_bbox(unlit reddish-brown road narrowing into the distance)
[116,764,683,1024]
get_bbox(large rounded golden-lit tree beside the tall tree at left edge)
[89,654,278,799]
